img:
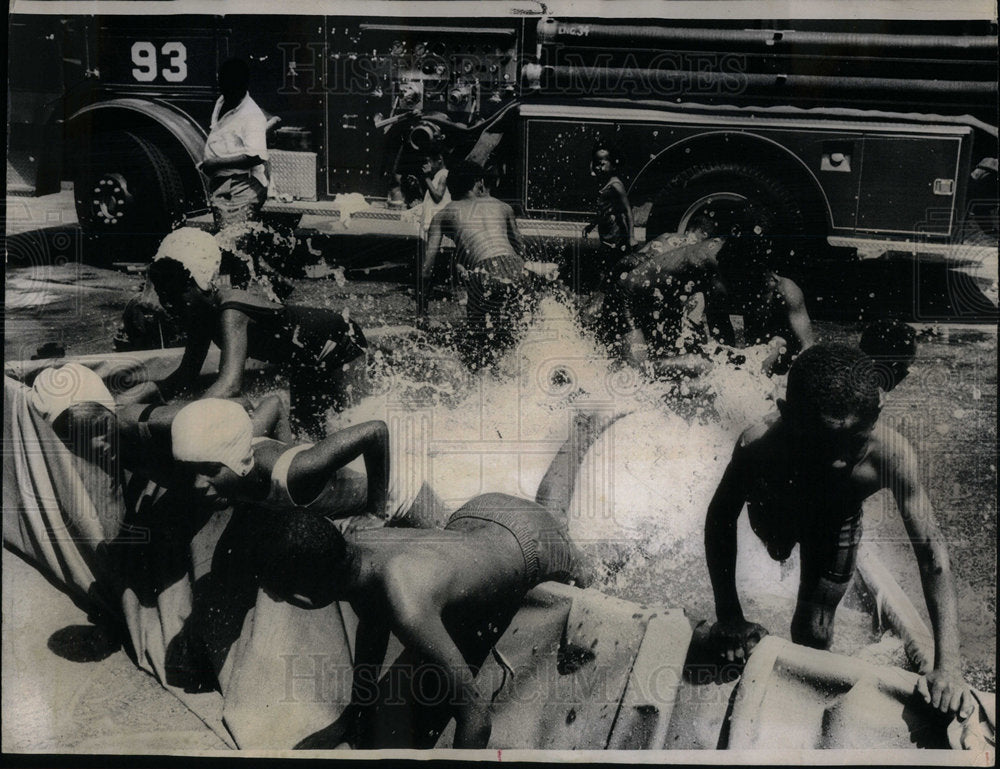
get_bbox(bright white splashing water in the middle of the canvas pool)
[337,297,804,603]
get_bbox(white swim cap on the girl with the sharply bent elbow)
[170,398,253,477]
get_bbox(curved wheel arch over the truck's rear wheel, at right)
[629,131,833,227]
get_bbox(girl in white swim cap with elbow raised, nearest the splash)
[170,398,389,518]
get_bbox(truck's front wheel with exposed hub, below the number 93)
[73,131,184,262]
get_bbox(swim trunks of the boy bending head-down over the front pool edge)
[445,494,581,590]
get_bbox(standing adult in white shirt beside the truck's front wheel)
[199,59,268,229]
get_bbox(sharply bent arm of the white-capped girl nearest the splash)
[288,420,389,514]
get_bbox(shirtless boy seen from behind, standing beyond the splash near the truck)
[417,160,528,363]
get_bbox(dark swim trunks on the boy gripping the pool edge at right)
[747,481,863,584]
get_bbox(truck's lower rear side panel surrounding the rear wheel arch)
[522,106,971,236]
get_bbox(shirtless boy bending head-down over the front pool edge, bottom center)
[262,418,612,749]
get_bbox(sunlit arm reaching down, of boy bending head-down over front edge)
[386,563,492,748]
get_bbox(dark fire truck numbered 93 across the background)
[8,0,997,256]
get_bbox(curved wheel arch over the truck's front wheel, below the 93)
[63,109,208,213]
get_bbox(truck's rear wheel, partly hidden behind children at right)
[646,162,826,265]
